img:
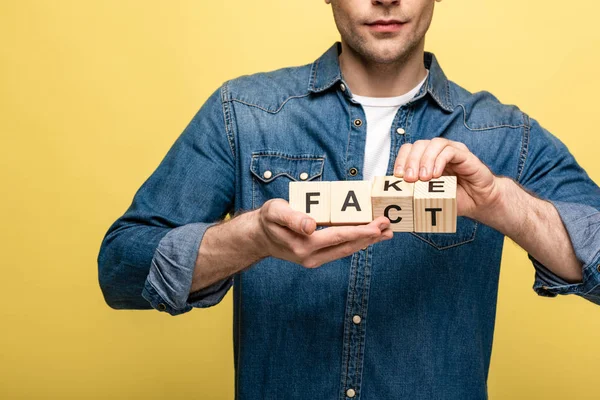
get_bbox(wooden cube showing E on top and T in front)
[414,176,456,233]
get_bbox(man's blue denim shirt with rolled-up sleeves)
[98,42,600,400]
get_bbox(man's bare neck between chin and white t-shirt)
[339,41,427,97]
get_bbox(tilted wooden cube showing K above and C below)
[371,176,415,232]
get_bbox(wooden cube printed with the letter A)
[331,181,373,225]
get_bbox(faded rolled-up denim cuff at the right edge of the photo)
[529,201,600,305]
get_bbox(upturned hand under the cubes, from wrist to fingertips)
[254,199,393,268]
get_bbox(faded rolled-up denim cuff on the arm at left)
[142,222,233,315]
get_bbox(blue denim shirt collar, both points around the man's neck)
[308,42,454,112]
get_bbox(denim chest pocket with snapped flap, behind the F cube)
[250,151,325,208]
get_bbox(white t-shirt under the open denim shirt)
[353,71,429,180]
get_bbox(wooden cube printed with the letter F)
[289,181,331,224]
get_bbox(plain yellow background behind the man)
[0,0,600,399]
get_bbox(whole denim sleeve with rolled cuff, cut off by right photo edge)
[518,115,600,305]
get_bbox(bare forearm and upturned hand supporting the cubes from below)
[190,199,393,292]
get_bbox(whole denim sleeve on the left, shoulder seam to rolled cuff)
[98,84,235,315]
